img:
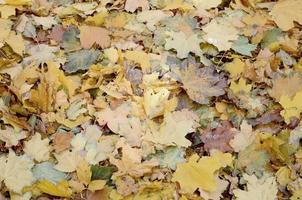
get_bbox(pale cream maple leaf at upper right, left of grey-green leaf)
[203,19,239,51]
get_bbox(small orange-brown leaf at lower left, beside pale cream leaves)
[53,132,74,153]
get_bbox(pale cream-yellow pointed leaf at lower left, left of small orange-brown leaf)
[24,133,50,162]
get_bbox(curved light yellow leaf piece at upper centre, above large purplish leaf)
[124,51,151,72]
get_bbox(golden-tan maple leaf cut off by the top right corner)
[270,0,302,31]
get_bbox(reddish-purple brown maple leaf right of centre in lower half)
[201,121,236,152]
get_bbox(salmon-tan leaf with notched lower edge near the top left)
[80,26,110,49]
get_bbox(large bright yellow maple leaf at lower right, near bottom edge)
[172,152,233,193]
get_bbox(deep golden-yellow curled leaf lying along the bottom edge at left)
[37,180,72,197]
